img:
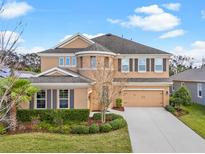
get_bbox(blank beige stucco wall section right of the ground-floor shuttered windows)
[74,88,89,109]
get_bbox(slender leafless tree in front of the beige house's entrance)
[92,57,126,123]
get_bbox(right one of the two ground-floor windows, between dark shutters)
[59,89,69,109]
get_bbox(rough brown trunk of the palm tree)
[9,105,17,132]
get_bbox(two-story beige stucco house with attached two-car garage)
[24,34,172,110]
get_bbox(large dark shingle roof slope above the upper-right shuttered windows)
[92,34,170,54]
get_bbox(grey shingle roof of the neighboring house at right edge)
[170,67,205,82]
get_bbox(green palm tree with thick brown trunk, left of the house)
[0,77,38,131]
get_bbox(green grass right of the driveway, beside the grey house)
[179,104,205,138]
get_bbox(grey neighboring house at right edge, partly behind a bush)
[171,67,205,105]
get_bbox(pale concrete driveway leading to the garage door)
[124,108,205,153]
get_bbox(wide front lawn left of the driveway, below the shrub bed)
[0,128,132,153]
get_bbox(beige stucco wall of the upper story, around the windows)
[41,55,169,78]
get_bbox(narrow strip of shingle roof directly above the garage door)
[113,78,171,82]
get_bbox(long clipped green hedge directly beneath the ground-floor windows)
[17,109,90,123]
